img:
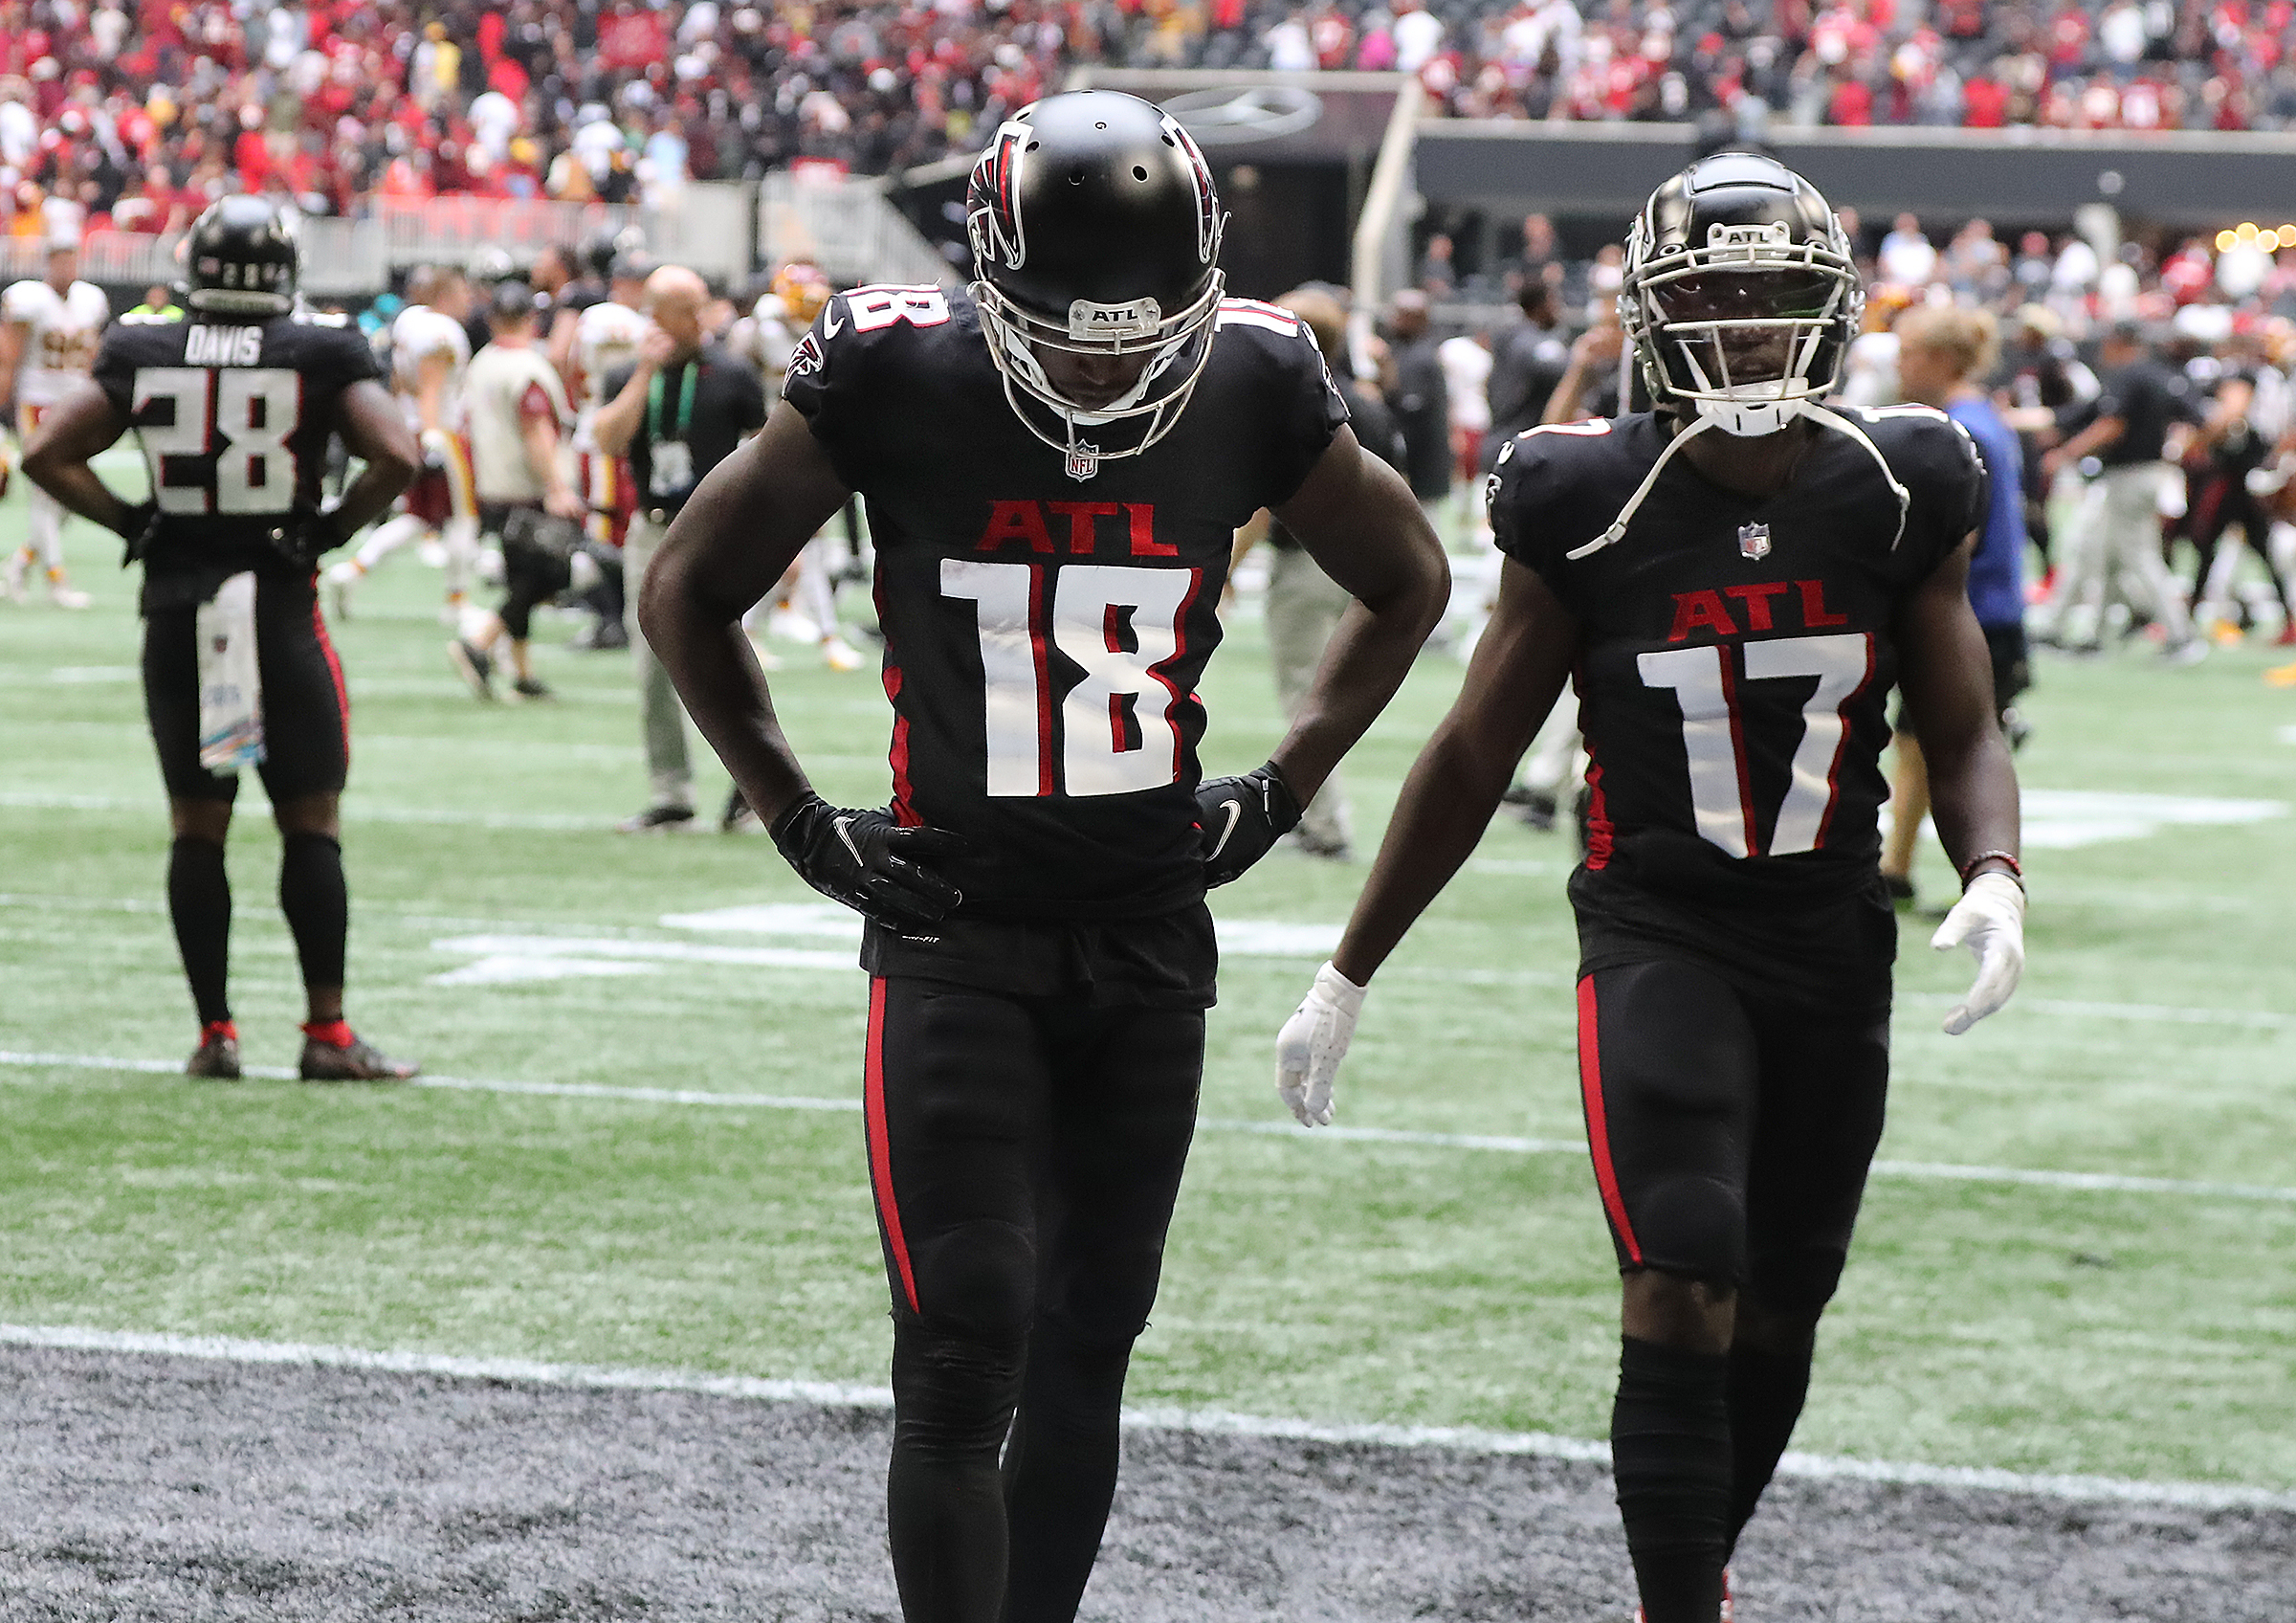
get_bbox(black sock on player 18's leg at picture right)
[1004,1324,1132,1623]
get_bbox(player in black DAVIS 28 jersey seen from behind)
[25,197,423,1081]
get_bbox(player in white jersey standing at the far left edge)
[0,230,113,609]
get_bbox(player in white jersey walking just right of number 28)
[326,266,477,627]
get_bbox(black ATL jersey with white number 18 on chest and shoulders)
[783,287,1348,919]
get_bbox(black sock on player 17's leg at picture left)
[1609,1336,1732,1623]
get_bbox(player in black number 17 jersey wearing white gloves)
[1276,154,2025,1623]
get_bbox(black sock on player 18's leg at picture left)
[886,1318,1024,1623]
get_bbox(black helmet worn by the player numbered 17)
[1619,151,1865,434]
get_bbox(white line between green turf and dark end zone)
[0,1324,2296,1513]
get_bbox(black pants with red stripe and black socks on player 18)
[866,978,1203,1623]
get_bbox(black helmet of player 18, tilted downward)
[964,90,1226,479]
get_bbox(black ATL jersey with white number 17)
[1490,407,1984,1000]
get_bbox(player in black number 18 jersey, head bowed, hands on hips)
[641,92,1446,1623]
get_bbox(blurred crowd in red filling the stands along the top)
[0,0,2296,234]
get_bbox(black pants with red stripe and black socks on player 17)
[1579,962,1889,1623]
